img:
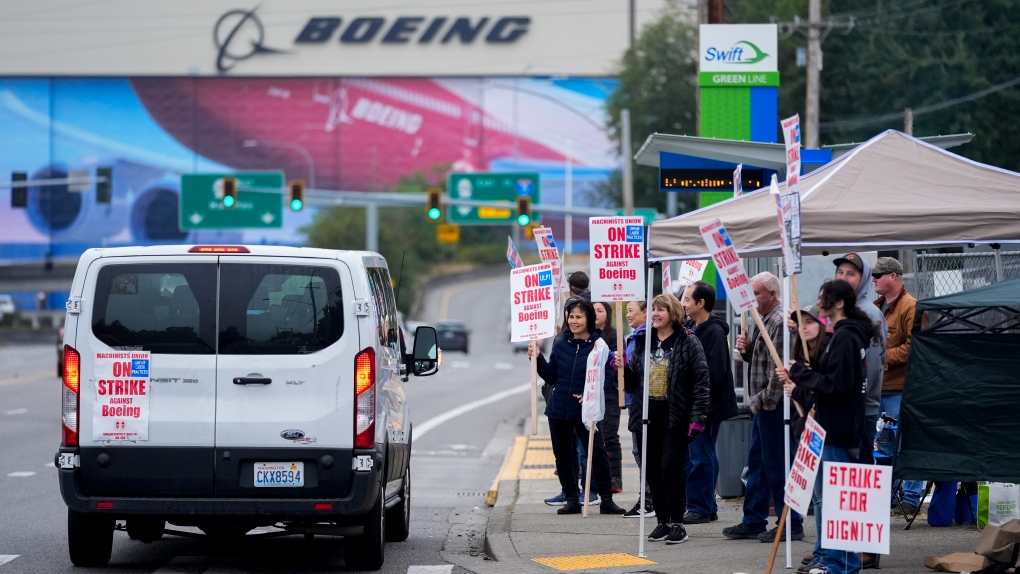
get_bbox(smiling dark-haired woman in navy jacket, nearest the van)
[527,297,624,514]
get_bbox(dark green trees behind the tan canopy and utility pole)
[727,0,1020,170]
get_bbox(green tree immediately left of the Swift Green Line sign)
[593,2,698,211]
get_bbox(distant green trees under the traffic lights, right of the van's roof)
[301,169,509,313]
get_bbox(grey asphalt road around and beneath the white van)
[0,277,529,574]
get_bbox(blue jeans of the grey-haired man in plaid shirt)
[744,409,804,532]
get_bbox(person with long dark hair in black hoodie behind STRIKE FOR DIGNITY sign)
[776,279,881,574]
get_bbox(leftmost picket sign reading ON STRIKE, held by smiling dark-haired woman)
[510,263,556,342]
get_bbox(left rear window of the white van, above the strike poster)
[92,263,216,355]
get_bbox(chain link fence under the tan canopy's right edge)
[912,251,1020,299]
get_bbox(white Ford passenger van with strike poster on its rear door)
[56,246,439,570]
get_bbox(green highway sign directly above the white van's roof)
[179,171,284,231]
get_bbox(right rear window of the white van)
[219,263,344,355]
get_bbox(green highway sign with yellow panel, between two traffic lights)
[447,171,542,225]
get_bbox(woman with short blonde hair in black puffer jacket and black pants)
[623,294,711,544]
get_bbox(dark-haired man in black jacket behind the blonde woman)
[680,281,736,524]
